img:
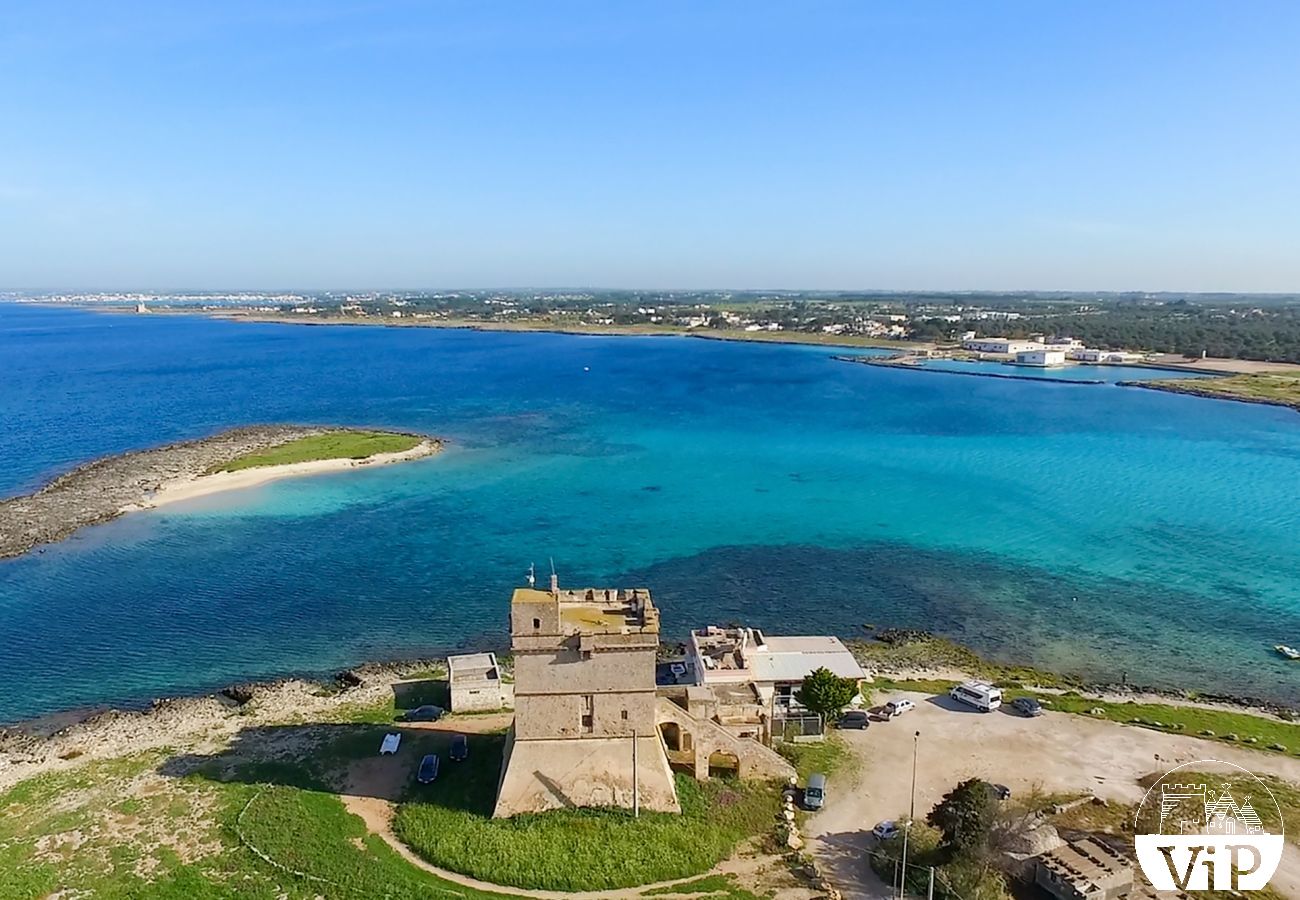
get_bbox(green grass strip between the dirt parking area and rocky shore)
[871,679,1300,756]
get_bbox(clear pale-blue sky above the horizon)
[0,0,1300,291]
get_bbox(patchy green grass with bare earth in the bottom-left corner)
[0,753,517,900]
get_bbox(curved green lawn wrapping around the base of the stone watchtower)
[394,735,780,891]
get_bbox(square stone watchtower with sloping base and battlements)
[493,576,680,815]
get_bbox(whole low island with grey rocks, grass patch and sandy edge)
[0,425,442,559]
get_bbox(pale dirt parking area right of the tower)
[806,693,1300,899]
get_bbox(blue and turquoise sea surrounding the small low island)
[0,306,1300,721]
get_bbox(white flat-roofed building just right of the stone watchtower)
[686,626,867,708]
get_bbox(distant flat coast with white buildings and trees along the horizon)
[10,290,1300,363]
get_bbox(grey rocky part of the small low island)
[0,425,437,559]
